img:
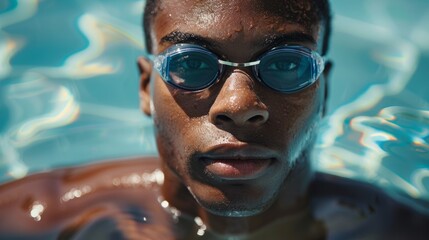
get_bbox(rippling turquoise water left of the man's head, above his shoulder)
[0,0,155,181]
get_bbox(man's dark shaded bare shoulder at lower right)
[311,174,429,239]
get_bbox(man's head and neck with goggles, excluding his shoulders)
[139,1,329,234]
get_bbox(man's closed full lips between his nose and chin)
[198,144,277,180]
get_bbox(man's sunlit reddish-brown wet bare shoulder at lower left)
[0,158,177,239]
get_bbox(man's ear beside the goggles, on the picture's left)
[137,57,152,116]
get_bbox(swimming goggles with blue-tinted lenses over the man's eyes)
[151,44,325,93]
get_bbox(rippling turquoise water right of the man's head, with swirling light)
[314,1,429,211]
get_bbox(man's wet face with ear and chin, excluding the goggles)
[140,0,327,216]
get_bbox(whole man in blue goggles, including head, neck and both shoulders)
[0,0,428,240]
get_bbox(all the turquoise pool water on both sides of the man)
[0,0,429,213]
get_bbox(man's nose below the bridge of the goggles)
[209,71,269,127]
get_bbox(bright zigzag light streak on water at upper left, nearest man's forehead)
[32,10,143,80]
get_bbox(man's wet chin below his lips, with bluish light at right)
[188,159,289,217]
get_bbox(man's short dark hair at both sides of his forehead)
[143,0,332,55]
